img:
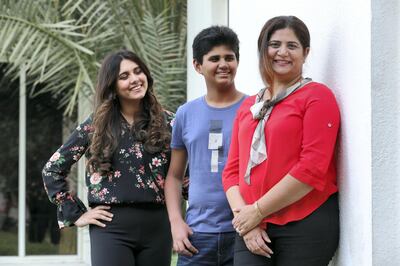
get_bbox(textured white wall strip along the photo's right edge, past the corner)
[372,0,400,266]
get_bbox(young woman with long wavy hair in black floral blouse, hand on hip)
[43,50,173,266]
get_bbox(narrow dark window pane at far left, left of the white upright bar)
[0,62,19,256]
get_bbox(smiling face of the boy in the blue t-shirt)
[193,45,238,89]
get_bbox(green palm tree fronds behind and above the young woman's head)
[0,0,186,114]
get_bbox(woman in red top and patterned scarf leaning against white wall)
[222,16,340,266]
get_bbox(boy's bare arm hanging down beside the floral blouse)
[164,149,198,256]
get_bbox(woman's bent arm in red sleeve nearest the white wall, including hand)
[234,85,340,234]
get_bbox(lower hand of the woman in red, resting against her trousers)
[243,226,274,258]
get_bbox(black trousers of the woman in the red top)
[234,193,339,266]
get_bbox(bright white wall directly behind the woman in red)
[188,0,376,266]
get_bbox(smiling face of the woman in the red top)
[267,28,309,80]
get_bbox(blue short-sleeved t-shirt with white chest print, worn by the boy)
[171,96,245,233]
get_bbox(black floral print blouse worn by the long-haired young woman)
[42,111,174,228]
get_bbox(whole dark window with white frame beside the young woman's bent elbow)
[0,64,88,265]
